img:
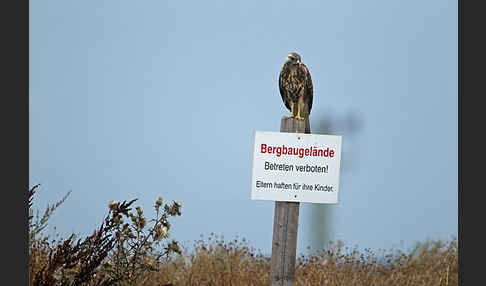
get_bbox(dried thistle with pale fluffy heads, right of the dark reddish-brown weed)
[101,197,182,285]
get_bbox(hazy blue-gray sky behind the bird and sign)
[29,0,458,253]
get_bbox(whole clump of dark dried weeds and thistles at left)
[28,185,182,286]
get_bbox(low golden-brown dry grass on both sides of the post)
[141,235,458,286]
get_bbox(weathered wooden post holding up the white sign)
[270,117,309,286]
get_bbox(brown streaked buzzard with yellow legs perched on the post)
[278,53,313,133]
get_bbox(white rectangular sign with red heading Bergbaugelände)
[250,131,341,204]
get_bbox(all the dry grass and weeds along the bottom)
[29,185,458,286]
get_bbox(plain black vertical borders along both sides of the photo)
[0,0,478,285]
